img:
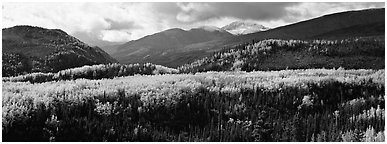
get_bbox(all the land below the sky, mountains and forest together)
[2,8,385,142]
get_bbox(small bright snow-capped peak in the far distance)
[221,21,270,35]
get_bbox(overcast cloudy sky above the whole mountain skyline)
[2,2,384,45]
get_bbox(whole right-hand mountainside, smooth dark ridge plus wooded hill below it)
[179,8,385,72]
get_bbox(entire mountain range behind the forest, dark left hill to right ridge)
[2,8,385,76]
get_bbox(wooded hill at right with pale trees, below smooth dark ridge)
[179,37,385,73]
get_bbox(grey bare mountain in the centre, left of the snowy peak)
[112,26,233,67]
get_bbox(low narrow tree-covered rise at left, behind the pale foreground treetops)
[3,63,178,83]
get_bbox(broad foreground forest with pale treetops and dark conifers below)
[2,69,385,141]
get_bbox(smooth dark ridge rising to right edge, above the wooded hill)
[238,8,385,40]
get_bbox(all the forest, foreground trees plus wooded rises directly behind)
[2,38,385,142]
